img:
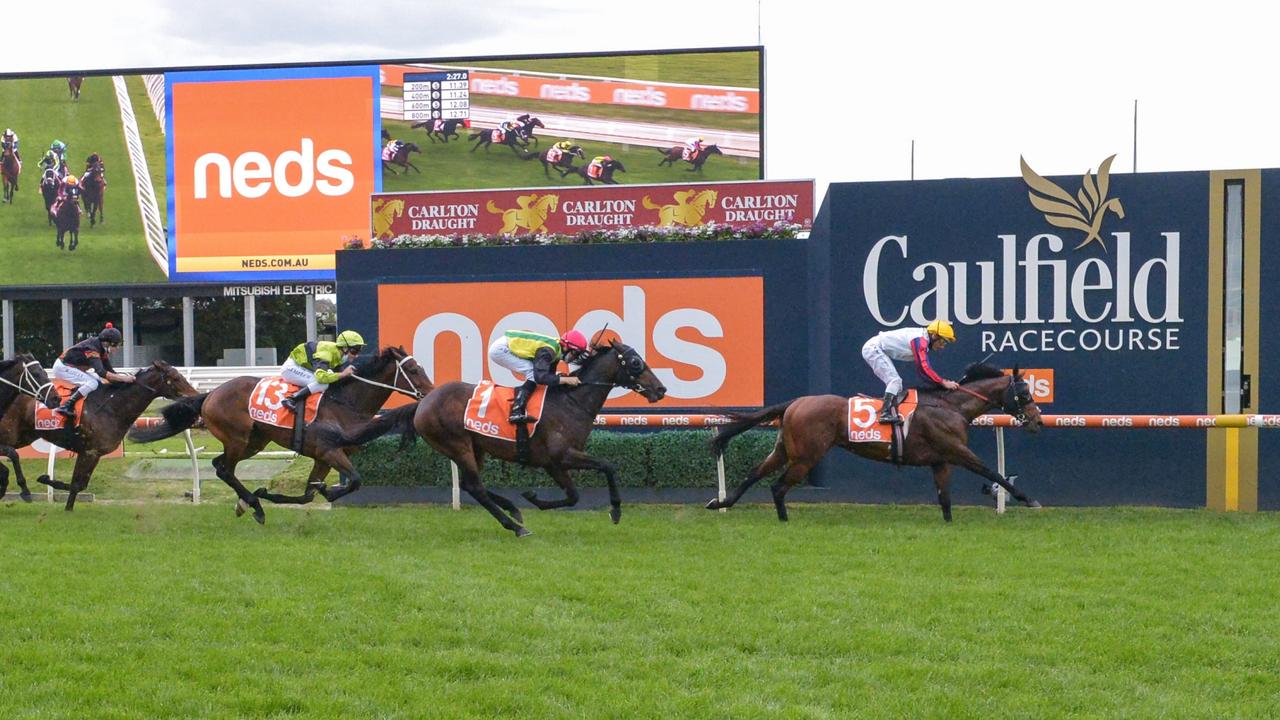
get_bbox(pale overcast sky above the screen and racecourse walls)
[0,0,1280,197]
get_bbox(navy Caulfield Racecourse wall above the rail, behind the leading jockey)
[831,156,1210,413]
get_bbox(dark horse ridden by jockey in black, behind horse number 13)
[0,360,196,510]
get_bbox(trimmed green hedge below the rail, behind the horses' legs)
[355,429,777,488]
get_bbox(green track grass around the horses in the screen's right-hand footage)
[383,119,760,192]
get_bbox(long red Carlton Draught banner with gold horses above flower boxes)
[370,181,814,240]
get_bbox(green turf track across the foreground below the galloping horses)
[0,502,1280,720]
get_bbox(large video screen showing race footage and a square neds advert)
[0,47,763,287]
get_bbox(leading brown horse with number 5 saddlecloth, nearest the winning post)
[707,363,1043,523]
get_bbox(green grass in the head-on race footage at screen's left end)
[0,77,164,284]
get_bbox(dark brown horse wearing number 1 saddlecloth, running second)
[319,341,667,537]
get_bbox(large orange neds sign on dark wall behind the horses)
[378,277,764,407]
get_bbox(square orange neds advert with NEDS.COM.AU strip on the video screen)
[170,68,378,275]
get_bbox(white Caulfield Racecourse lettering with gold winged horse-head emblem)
[861,158,1182,354]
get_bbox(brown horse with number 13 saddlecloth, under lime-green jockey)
[129,347,433,523]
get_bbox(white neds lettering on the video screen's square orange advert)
[195,137,356,200]
